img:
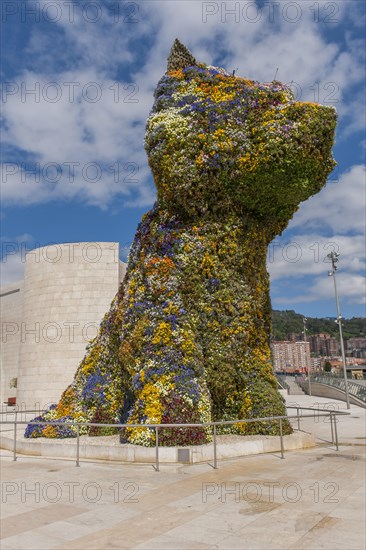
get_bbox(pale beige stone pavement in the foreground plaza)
[1,395,366,550]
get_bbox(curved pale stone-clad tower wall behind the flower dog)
[17,242,125,410]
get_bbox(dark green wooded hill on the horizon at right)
[272,309,366,340]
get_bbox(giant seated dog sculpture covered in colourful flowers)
[26,40,336,445]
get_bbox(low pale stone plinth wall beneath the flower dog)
[0,432,315,464]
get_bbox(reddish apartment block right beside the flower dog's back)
[271,340,311,373]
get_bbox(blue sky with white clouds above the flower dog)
[1,0,366,317]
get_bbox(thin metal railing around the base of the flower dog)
[0,406,350,472]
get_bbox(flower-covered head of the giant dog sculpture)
[145,40,336,225]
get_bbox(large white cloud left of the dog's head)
[1,70,154,207]
